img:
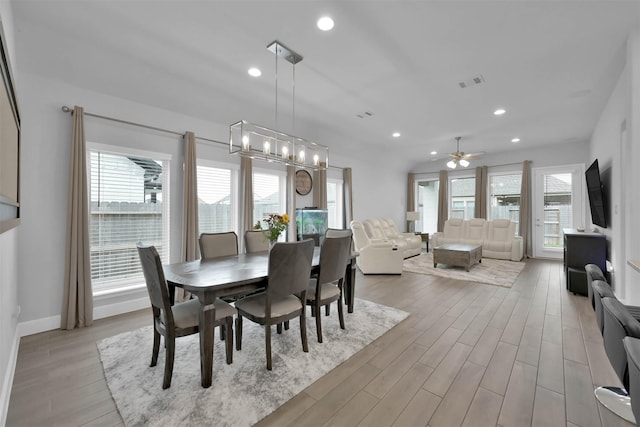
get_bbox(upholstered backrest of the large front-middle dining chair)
[267,239,314,295]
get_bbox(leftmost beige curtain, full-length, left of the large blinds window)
[60,106,93,329]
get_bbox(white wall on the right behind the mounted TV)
[590,29,640,305]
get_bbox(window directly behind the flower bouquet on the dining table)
[253,171,286,231]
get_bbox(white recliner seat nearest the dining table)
[351,221,404,274]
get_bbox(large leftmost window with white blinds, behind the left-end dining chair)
[88,144,169,294]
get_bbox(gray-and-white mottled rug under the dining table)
[98,299,409,426]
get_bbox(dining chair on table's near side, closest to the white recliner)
[306,230,351,342]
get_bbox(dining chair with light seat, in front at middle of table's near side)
[235,239,314,370]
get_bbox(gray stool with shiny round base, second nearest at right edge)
[595,297,640,423]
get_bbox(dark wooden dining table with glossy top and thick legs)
[163,247,358,388]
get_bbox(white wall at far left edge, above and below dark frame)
[0,1,20,425]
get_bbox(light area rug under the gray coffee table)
[403,252,525,288]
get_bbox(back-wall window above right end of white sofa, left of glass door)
[489,173,522,235]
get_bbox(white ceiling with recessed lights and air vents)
[12,0,640,169]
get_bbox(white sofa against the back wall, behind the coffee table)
[431,218,523,261]
